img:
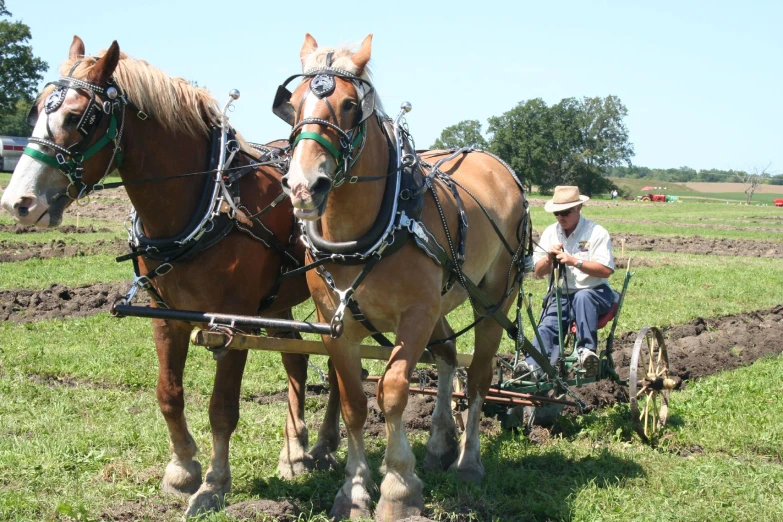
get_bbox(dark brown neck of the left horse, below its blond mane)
[120,120,209,238]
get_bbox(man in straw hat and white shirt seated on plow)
[521,186,614,377]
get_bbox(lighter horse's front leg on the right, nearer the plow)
[375,308,438,522]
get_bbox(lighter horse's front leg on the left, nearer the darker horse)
[323,335,374,520]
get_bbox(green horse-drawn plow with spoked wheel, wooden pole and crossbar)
[112,254,679,442]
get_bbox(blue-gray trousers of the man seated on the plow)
[527,285,614,366]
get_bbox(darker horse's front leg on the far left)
[152,319,201,495]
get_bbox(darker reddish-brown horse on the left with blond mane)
[2,37,339,514]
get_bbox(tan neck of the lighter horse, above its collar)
[321,122,390,242]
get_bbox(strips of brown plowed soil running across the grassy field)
[0,187,783,522]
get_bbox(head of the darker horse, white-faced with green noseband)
[0,36,121,227]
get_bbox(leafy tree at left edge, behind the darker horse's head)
[0,0,48,135]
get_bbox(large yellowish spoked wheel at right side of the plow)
[628,326,676,442]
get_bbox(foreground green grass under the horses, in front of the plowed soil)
[0,316,783,521]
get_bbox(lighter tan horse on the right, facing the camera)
[275,34,526,521]
